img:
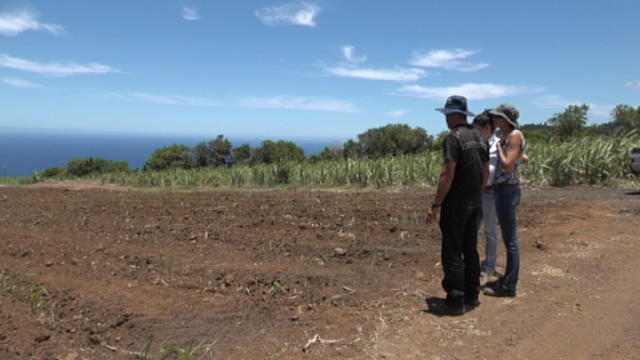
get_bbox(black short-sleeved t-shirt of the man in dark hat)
[443,125,489,208]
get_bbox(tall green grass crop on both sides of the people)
[76,133,640,188]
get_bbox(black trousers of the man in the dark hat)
[440,205,482,307]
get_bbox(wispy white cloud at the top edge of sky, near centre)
[255,2,322,27]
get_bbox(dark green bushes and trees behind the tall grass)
[39,104,640,178]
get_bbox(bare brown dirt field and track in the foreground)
[0,184,640,360]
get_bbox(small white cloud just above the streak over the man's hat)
[409,49,489,72]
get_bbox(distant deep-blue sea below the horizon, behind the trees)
[0,131,344,176]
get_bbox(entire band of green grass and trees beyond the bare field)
[28,104,640,188]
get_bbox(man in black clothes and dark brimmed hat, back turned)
[427,95,489,315]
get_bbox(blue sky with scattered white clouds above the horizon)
[0,0,640,139]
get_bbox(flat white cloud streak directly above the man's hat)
[396,83,541,100]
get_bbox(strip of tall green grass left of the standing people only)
[96,153,442,188]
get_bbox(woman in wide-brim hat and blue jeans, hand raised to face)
[484,104,526,297]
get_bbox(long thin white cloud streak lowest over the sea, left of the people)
[111,92,360,113]
